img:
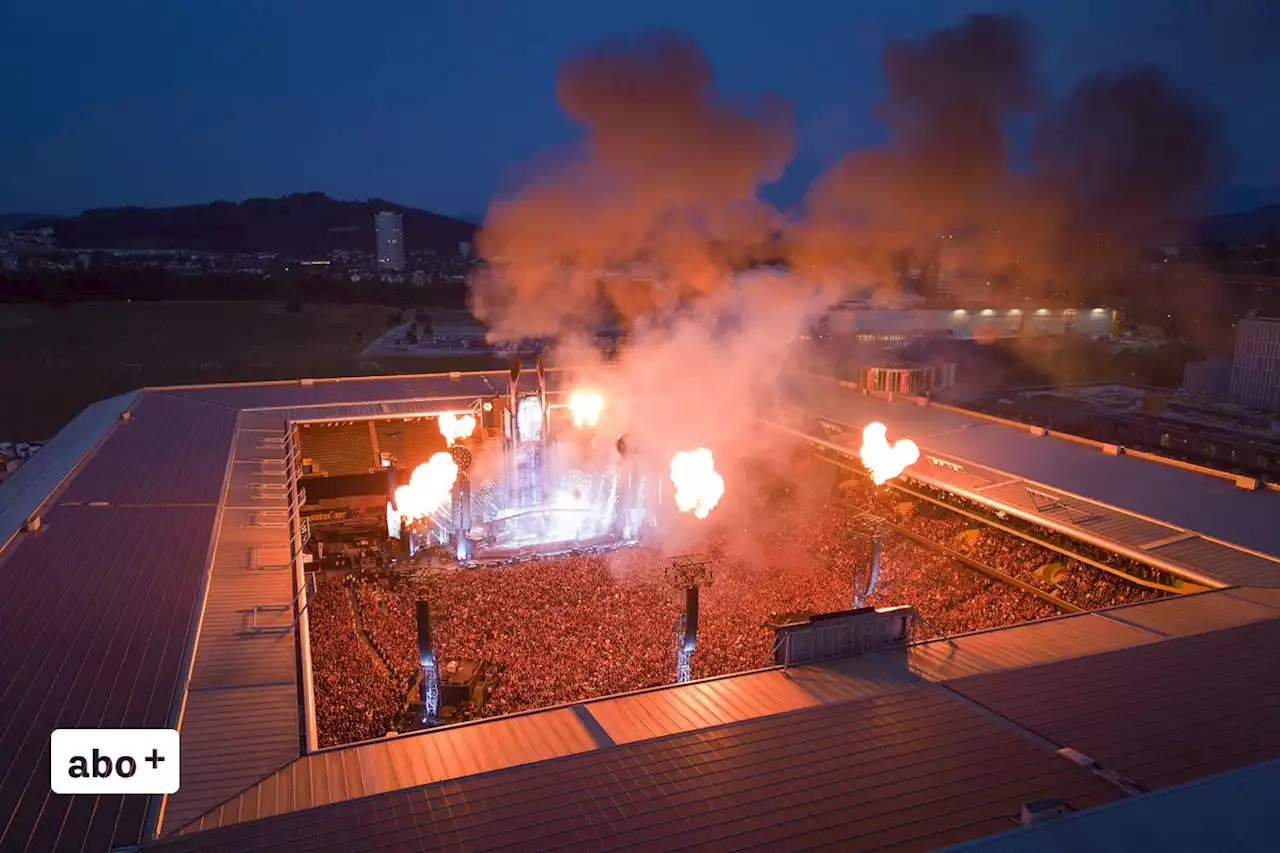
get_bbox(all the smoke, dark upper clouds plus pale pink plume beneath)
[472,15,1220,548]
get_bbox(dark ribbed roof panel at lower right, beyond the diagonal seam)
[950,620,1280,788]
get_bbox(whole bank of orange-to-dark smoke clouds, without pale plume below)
[472,15,1226,327]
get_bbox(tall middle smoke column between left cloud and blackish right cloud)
[792,15,1037,280]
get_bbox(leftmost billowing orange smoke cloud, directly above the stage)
[474,32,795,337]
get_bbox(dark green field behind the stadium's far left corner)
[0,302,495,441]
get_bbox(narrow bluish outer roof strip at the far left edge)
[0,391,138,547]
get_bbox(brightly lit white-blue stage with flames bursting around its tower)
[387,364,659,565]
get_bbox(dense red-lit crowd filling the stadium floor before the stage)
[311,484,1161,745]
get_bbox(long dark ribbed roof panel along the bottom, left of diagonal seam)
[148,688,1117,853]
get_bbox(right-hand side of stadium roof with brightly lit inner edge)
[792,379,1280,587]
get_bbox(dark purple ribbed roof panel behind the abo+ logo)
[0,506,215,853]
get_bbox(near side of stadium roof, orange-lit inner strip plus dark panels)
[147,590,1280,853]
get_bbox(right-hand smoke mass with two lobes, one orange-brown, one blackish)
[791,15,1226,295]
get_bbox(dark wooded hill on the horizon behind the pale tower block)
[28,192,476,257]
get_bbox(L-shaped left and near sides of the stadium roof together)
[0,373,1280,852]
